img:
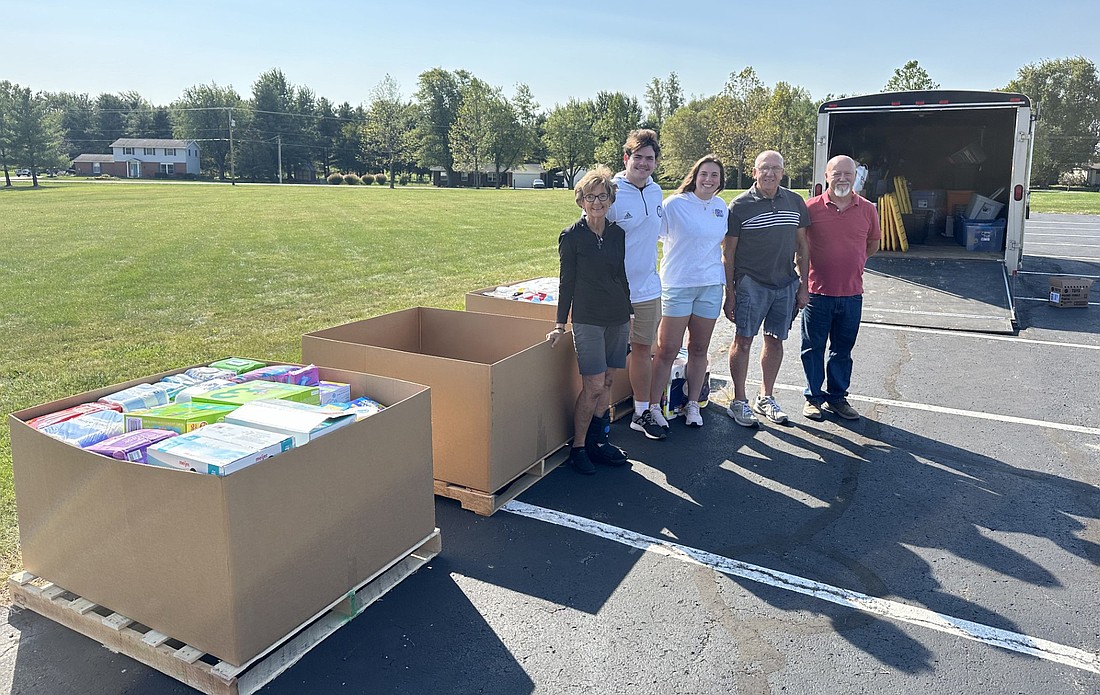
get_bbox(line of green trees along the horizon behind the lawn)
[0,57,1100,188]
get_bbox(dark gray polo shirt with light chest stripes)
[726,184,810,289]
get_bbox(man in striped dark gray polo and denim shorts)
[722,150,810,427]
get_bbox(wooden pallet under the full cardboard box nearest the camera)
[8,529,441,695]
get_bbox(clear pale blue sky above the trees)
[8,0,1100,109]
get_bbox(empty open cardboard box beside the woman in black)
[301,307,578,494]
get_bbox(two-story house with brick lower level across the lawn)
[73,137,199,178]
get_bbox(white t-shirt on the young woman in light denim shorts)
[661,192,727,287]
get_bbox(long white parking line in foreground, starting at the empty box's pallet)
[502,500,1100,673]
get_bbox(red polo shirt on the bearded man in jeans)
[806,192,882,297]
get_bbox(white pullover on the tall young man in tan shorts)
[607,172,663,301]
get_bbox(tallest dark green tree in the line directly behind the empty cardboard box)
[416,67,469,186]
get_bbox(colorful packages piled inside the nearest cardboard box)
[28,357,384,476]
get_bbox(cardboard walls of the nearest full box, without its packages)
[9,362,436,665]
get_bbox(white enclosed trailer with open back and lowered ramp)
[812,90,1035,332]
